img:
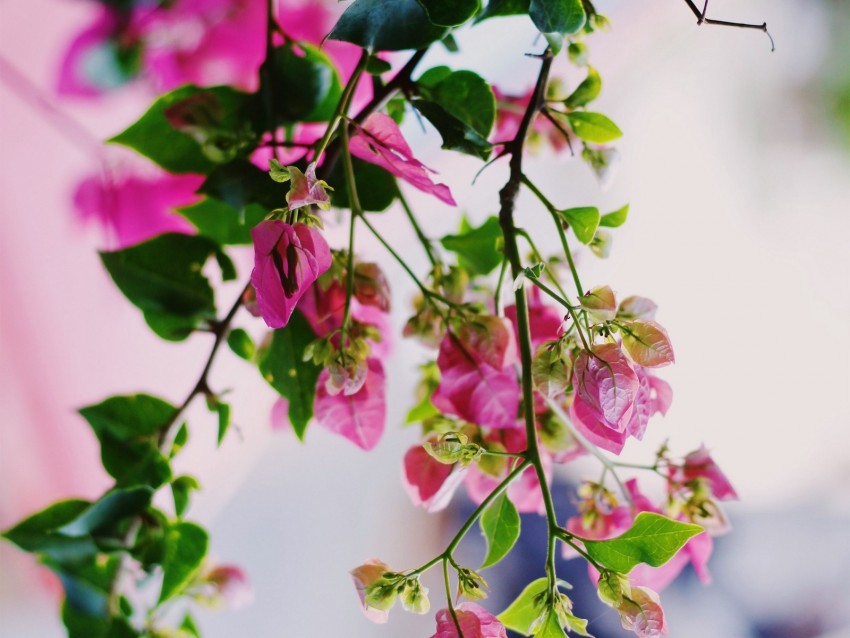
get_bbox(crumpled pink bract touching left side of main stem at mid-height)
[431,334,520,428]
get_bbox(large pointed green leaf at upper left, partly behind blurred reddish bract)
[107,85,248,173]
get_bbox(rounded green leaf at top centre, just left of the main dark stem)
[420,67,496,141]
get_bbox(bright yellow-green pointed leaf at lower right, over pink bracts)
[583,512,703,574]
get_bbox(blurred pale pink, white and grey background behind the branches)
[0,0,850,638]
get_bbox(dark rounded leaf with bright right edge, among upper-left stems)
[273,42,342,124]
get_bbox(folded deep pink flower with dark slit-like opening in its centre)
[251,220,331,328]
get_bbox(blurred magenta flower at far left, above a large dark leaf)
[74,172,204,249]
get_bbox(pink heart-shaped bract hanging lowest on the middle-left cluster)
[314,358,387,451]
